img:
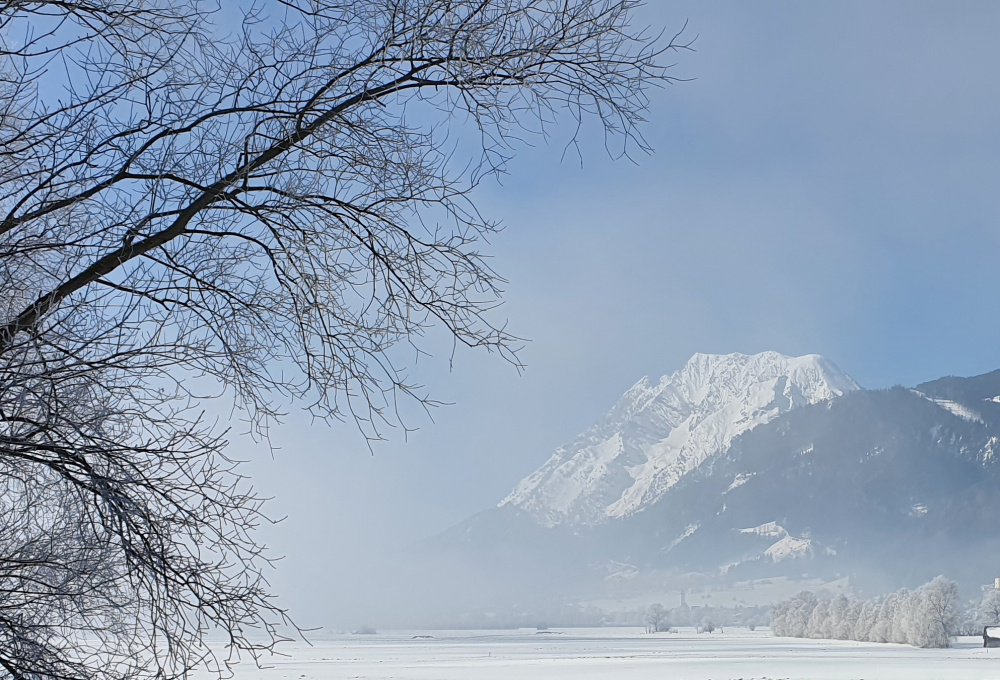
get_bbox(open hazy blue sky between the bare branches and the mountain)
[234,0,1000,625]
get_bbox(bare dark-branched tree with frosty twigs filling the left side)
[0,0,682,680]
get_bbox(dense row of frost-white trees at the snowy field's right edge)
[771,576,959,647]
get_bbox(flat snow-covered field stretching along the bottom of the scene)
[205,628,1000,680]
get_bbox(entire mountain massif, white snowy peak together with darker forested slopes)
[428,353,1000,597]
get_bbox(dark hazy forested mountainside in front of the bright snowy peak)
[619,380,1000,588]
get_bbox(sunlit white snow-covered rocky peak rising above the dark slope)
[500,352,860,527]
